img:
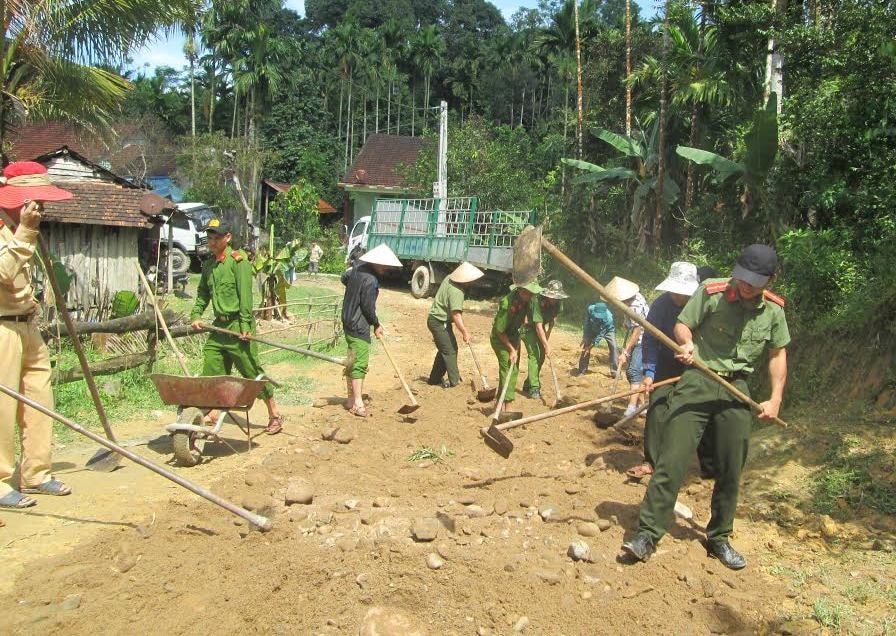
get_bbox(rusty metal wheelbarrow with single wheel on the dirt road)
[149,373,270,466]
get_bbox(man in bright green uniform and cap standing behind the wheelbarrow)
[190,219,283,435]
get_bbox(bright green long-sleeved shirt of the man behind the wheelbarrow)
[190,250,255,333]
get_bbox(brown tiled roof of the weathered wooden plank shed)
[44,181,175,228]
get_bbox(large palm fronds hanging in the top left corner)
[0,0,191,153]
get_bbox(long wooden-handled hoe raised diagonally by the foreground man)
[513,225,787,428]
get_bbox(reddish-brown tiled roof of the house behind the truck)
[341,134,425,188]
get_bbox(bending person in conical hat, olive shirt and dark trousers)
[426,261,485,389]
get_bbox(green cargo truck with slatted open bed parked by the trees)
[346,197,536,298]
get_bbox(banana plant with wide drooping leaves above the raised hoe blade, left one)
[561,123,681,252]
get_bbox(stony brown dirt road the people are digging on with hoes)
[0,290,886,635]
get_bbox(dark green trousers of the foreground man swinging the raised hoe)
[638,369,753,541]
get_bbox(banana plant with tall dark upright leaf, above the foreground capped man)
[675,93,778,218]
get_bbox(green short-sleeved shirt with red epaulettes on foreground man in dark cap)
[678,279,790,374]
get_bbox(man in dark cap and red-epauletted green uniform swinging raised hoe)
[622,244,790,570]
